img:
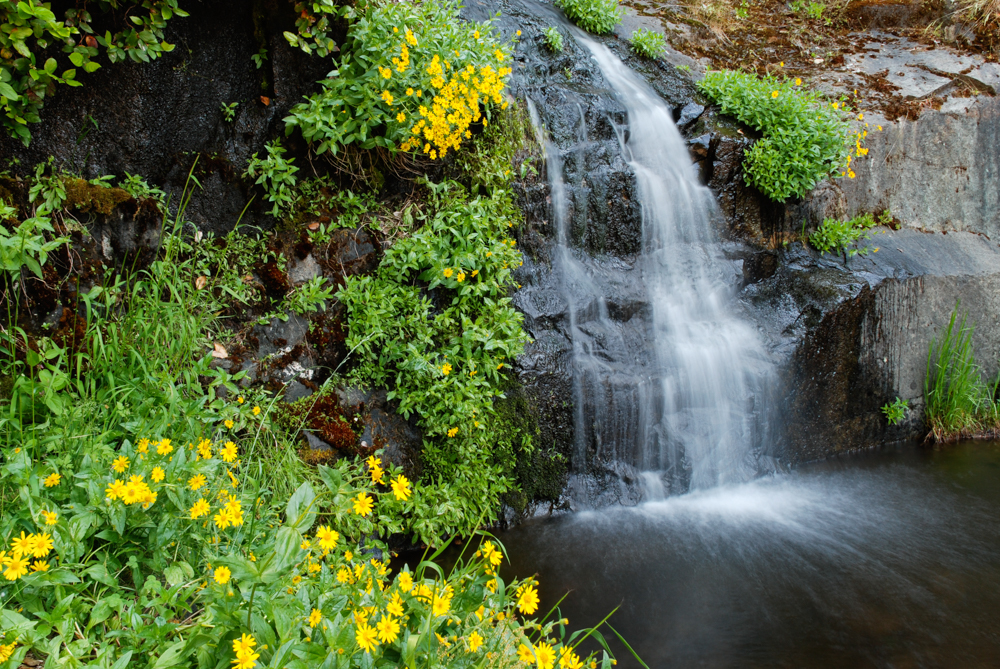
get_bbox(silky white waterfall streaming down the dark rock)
[531,36,771,497]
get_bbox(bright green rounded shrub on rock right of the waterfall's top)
[698,70,867,202]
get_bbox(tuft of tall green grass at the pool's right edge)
[924,305,998,441]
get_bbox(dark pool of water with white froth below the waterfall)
[500,442,1000,669]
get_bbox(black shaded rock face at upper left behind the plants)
[0,0,330,233]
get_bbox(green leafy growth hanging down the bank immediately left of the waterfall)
[337,183,527,533]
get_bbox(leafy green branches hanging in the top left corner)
[0,0,187,145]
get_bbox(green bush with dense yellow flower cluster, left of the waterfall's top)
[285,0,511,160]
